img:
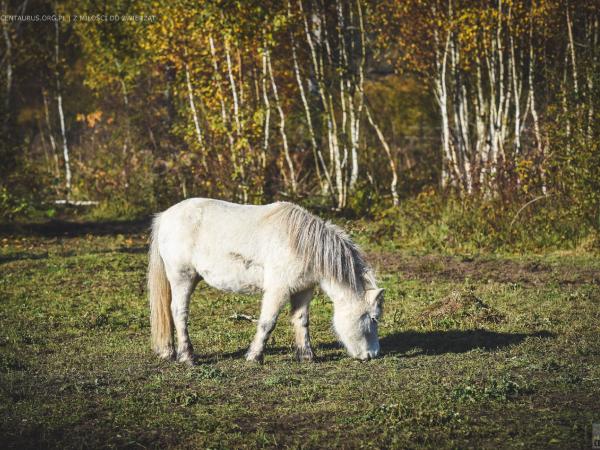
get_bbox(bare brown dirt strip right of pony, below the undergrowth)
[367,252,600,286]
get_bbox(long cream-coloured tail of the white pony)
[148,216,175,359]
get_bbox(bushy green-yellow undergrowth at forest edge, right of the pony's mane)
[349,192,600,254]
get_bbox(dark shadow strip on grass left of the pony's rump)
[0,219,150,238]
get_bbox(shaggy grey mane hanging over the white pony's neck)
[273,202,369,290]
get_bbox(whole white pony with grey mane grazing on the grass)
[148,198,383,364]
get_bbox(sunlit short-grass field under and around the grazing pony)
[0,223,600,449]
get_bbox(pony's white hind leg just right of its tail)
[167,270,200,364]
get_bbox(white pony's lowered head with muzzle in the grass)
[333,287,383,360]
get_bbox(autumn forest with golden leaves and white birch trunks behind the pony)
[0,0,600,251]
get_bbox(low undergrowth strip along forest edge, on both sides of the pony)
[0,190,600,255]
